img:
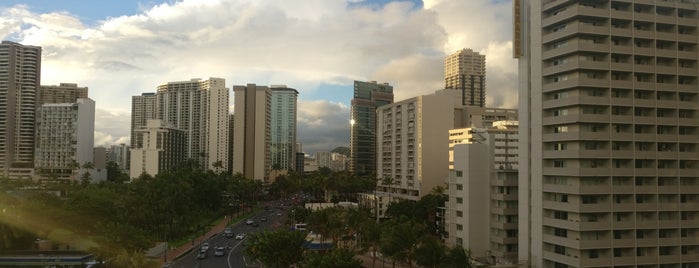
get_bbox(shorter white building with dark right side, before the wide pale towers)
[129,119,187,178]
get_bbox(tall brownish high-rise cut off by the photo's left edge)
[0,41,41,178]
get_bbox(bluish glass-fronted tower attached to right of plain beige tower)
[269,86,299,171]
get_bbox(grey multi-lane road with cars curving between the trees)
[171,208,285,268]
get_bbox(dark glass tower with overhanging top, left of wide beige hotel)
[350,81,393,176]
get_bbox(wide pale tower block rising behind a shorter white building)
[156,78,229,171]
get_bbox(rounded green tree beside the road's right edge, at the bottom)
[245,229,306,268]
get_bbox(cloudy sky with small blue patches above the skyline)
[0,0,517,154]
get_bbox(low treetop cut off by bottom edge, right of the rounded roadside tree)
[301,248,362,268]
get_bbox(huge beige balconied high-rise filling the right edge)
[514,0,699,267]
